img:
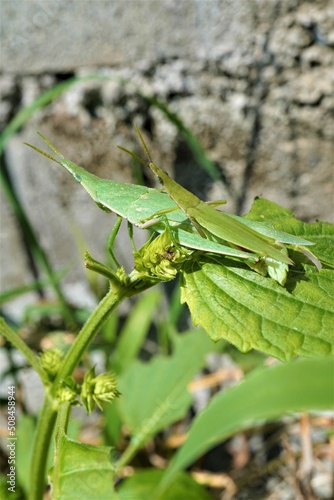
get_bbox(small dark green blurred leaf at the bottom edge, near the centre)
[117,469,211,500]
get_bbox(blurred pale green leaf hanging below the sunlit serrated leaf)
[118,331,214,446]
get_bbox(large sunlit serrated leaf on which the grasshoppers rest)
[181,200,334,360]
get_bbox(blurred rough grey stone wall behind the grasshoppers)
[0,0,334,310]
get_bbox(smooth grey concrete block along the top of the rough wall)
[1,0,262,74]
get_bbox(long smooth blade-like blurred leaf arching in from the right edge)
[163,357,334,485]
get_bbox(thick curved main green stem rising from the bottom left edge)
[29,287,126,500]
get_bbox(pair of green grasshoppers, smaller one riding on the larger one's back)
[28,132,313,279]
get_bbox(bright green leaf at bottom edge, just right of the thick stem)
[51,435,118,500]
